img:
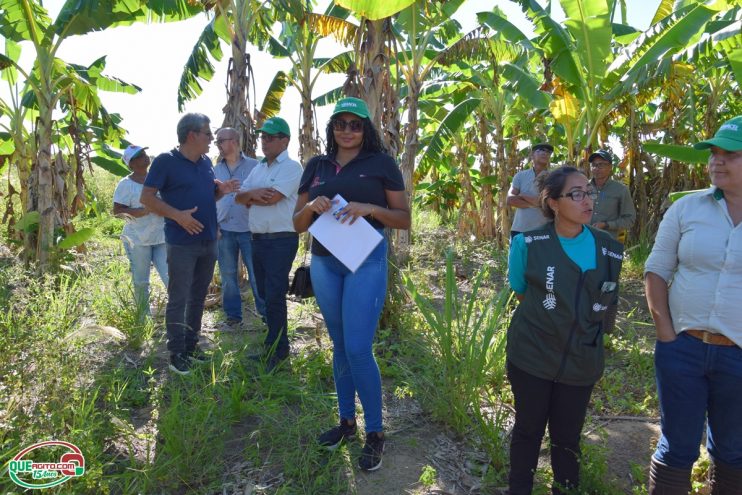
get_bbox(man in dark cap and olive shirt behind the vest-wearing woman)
[588,150,636,240]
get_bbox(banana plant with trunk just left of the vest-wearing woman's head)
[415,8,551,245]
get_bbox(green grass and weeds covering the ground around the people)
[0,171,668,494]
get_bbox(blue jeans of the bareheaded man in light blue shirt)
[218,230,265,320]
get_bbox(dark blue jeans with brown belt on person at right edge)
[654,332,742,469]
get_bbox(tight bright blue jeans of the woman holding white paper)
[309,239,387,433]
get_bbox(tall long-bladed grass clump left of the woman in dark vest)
[404,251,510,468]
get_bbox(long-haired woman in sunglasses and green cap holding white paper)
[294,98,410,471]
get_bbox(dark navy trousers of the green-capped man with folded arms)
[252,235,299,359]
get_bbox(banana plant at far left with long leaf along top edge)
[0,0,196,270]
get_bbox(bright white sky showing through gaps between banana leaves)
[8,0,660,163]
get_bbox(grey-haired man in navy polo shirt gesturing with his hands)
[140,113,239,375]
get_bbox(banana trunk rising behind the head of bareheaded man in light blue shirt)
[222,35,257,157]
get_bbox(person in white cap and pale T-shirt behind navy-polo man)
[113,144,168,315]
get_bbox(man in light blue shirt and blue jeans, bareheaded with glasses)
[214,127,265,325]
